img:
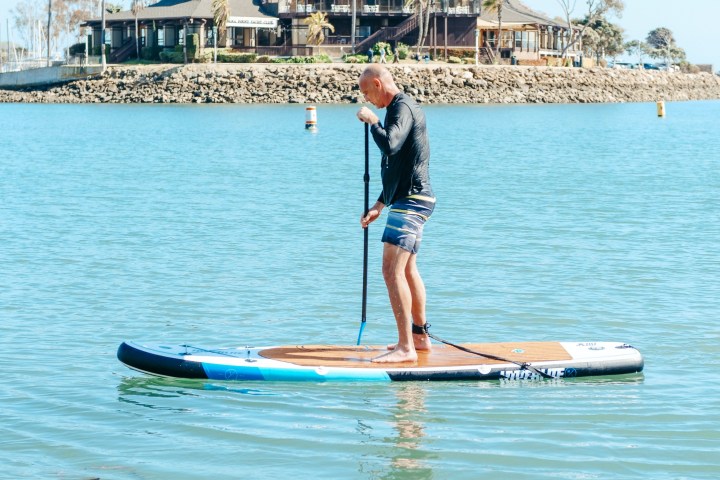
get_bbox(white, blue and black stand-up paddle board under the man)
[117,342,643,382]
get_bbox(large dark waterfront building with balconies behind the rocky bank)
[85,0,579,63]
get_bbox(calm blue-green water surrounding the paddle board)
[0,102,720,479]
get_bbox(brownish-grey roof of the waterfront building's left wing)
[87,0,274,24]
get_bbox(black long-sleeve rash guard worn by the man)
[370,93,434,205]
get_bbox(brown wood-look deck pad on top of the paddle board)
[259,342,572,368]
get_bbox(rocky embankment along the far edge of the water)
[0,63,720,104]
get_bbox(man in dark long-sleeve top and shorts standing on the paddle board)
[357,64,435,363]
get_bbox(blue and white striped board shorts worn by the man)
[382,195,435,253]
